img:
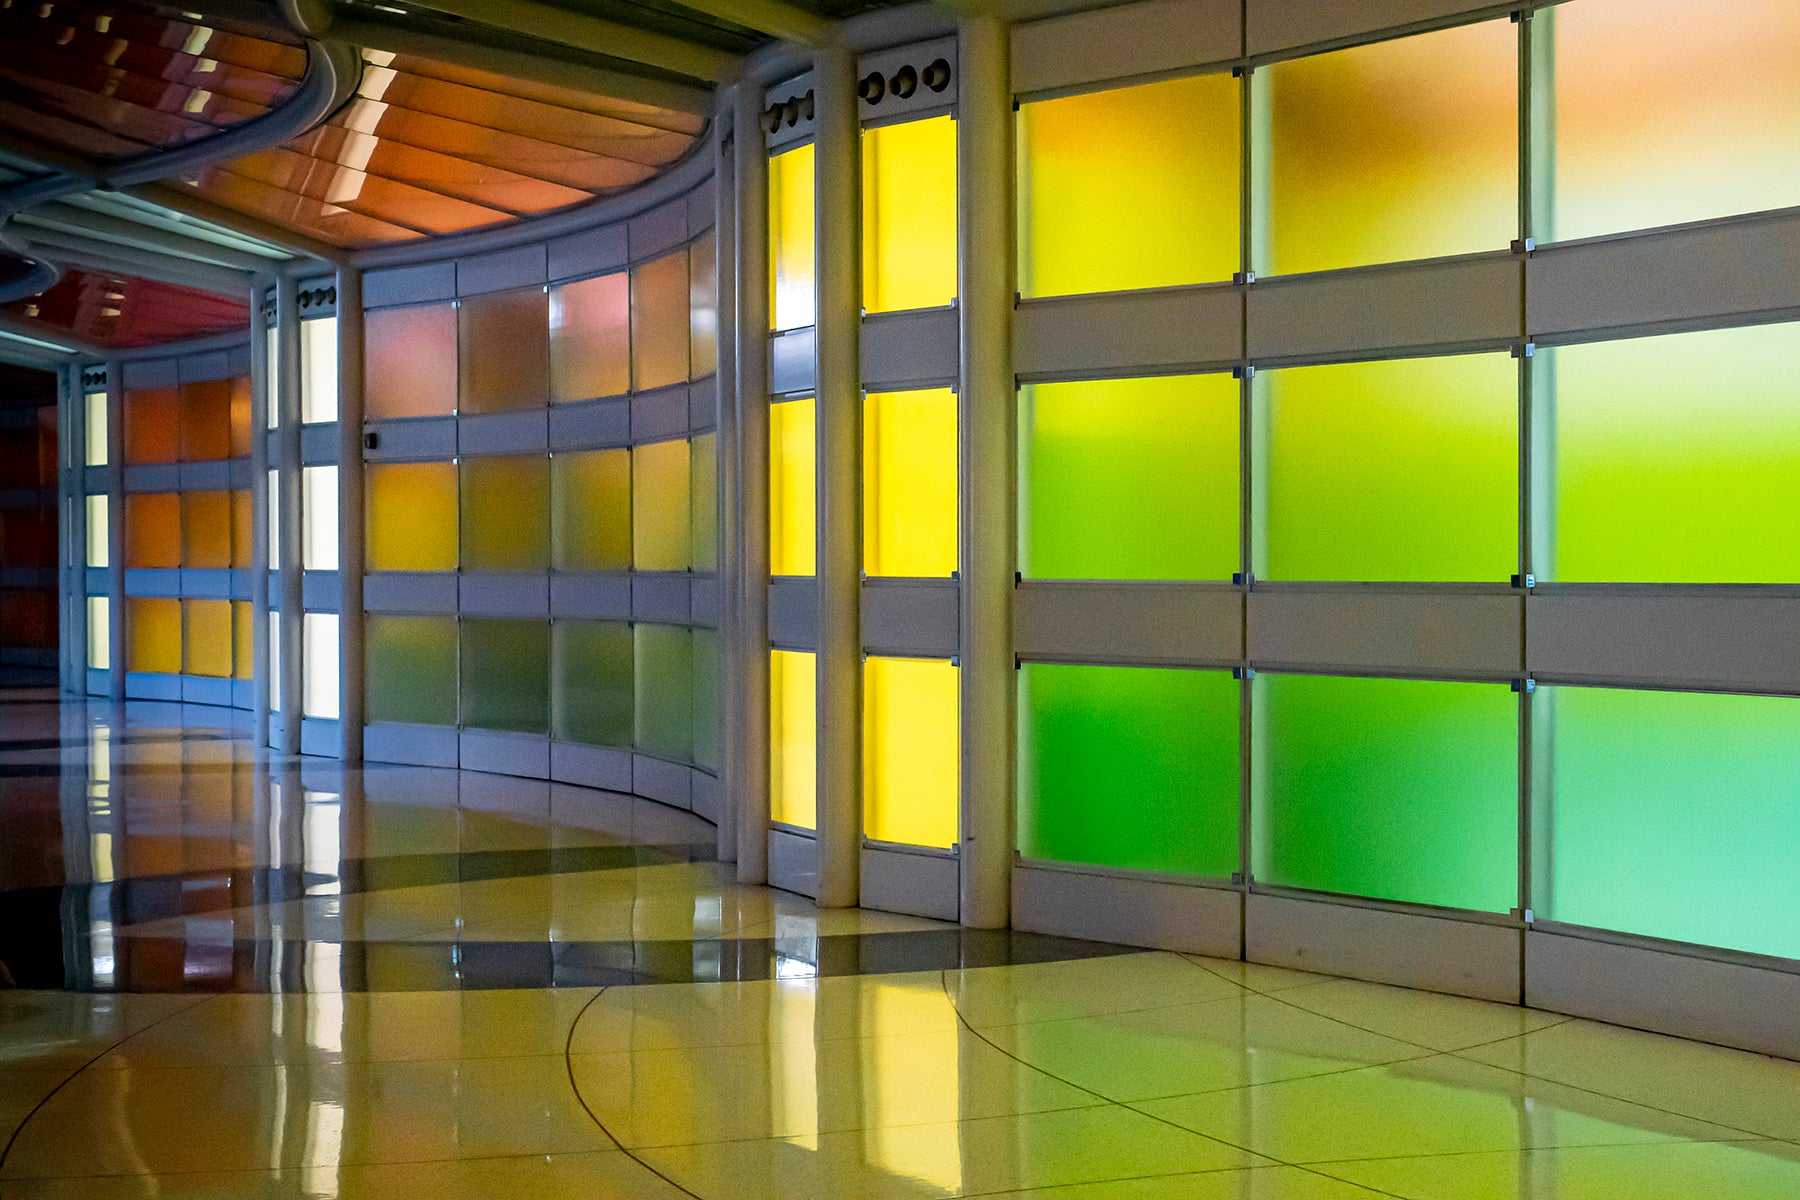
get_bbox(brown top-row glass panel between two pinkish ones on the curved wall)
[457,288,551,414]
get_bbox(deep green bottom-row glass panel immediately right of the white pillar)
[1019,662,1240,878]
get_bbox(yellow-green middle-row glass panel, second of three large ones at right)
[1253,354,1519,581]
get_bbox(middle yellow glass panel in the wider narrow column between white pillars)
[862,387,956,576]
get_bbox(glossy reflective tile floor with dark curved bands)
[0,691,1800,1200]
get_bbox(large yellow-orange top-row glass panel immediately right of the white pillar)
[1019,74,1242,297]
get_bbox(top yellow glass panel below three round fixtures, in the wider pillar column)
[862,117,956,313]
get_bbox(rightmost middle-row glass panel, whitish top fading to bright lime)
[1535,324,1800,583]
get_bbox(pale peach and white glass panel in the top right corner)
[1532,0,1800,241]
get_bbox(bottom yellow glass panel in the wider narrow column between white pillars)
[862,657,961,846]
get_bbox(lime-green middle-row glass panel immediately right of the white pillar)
[1019,374,1240,579]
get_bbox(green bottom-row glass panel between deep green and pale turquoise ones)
[1251,675,1519,912]
